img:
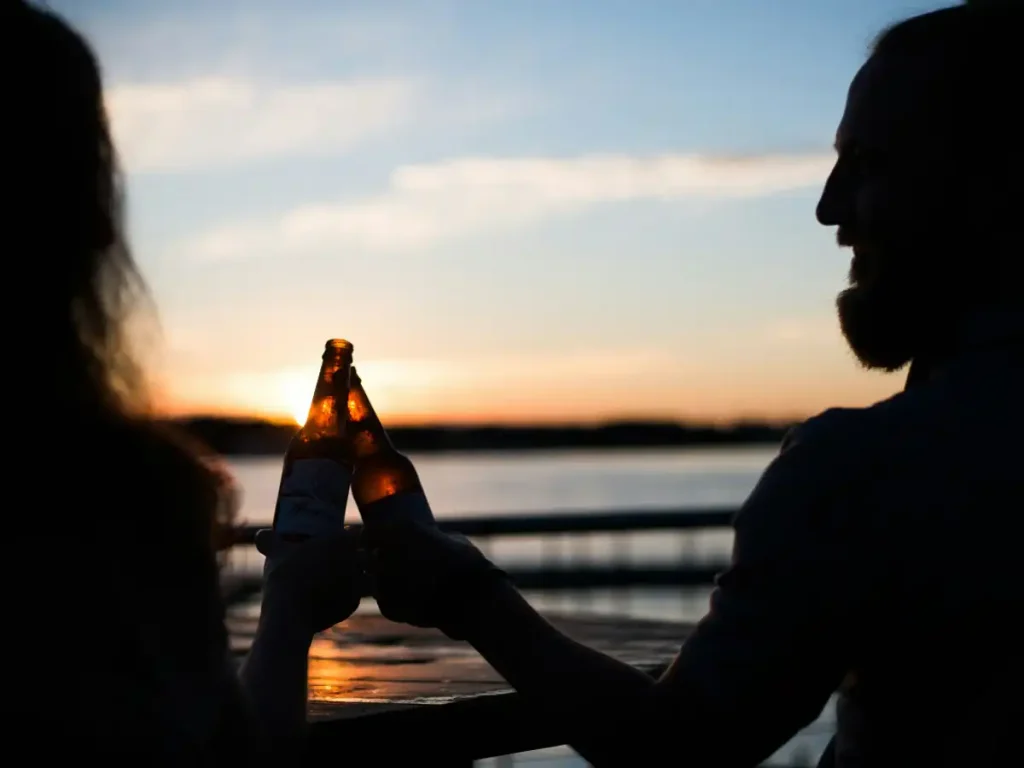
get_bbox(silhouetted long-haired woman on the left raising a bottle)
[0,0,358,765]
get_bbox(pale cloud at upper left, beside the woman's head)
[106,77,420,173]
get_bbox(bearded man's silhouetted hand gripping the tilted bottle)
[364,522,505,639]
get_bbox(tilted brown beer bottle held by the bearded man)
[348,369,434,526]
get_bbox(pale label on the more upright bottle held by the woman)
[275,459,352,536]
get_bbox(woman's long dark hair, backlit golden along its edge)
[6,0,231,544]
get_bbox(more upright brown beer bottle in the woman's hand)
[273,339,352,541]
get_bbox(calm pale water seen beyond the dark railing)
[229,446,831,768]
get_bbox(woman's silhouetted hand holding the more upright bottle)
[256,528,366,636]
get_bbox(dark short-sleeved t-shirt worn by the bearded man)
[665,311,1024,768]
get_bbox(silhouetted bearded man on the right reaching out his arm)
[364,2,1024,768]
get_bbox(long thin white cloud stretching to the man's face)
[182,155,833,261]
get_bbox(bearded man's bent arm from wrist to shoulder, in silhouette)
[456,414,872,766]
